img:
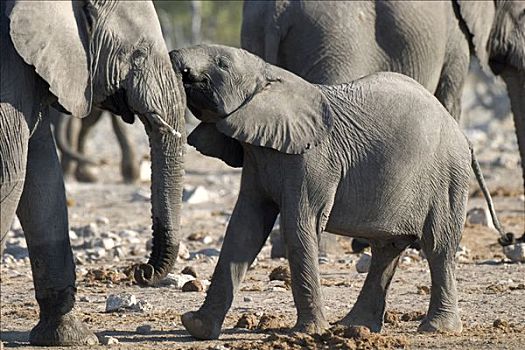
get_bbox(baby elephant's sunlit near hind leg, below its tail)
[419,177,468,332]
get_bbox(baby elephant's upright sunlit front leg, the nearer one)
[281,213,329,333]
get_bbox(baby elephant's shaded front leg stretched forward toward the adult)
[182,192,278,339]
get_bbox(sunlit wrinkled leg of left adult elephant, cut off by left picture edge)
[0,103,29,253]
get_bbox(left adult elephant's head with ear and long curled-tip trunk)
[8,0,185,285]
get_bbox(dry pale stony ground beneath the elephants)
[1,118,525,349]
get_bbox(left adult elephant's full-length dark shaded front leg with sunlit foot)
[17,116,98,345]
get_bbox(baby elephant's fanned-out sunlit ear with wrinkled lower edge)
[216,66,332,154]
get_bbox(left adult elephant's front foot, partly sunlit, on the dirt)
[29,312,98,346]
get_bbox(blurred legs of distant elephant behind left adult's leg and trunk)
[49,108,140,183]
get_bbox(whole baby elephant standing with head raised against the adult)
[171,45,499,339]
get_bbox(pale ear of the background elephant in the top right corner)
[457,0,496,72]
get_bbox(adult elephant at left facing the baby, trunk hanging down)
[0,1,185,345]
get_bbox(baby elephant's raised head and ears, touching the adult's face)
[170,45,332,167]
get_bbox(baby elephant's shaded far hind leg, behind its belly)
[340,239,411,332]
